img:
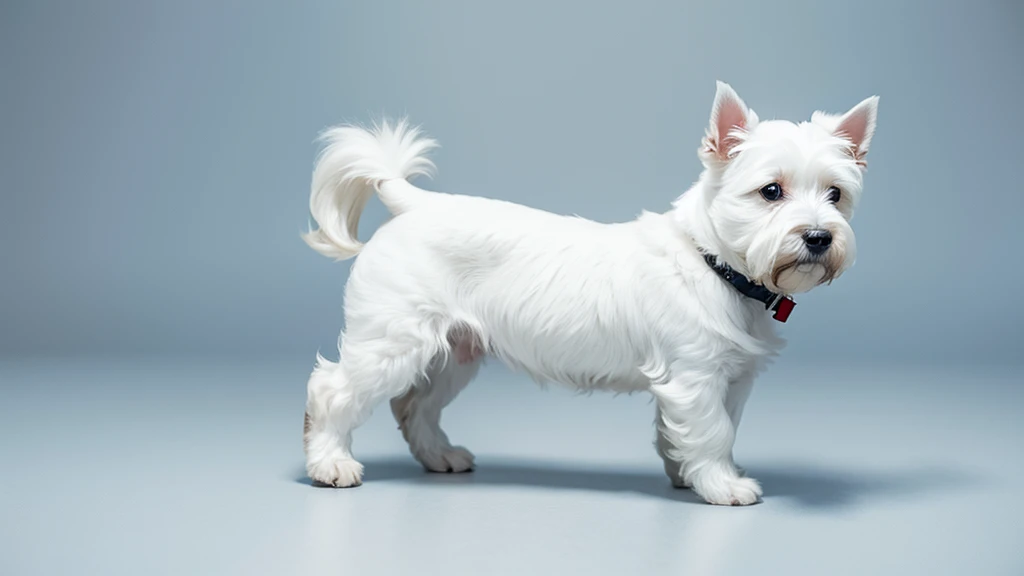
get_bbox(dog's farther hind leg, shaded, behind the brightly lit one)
[391,341,482,472]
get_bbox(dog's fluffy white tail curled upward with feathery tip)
[302,120,437,260]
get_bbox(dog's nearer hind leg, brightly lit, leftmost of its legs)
[304,336,436,488]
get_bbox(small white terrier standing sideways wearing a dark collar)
[304,83,878,505]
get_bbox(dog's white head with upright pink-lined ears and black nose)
[699,82,879,294]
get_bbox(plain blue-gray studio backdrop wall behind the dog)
[0,0,1024,363]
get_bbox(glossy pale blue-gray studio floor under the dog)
[0,360,1024,576]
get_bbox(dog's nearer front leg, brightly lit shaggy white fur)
[651,373,761,505]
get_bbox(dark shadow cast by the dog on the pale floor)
[296,457,973,508]
